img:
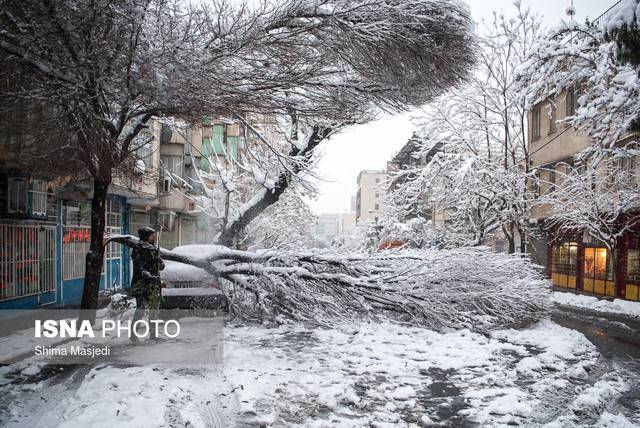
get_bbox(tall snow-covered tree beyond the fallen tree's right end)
[389,3,540,252]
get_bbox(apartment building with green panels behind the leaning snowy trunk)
[152,114,280,248]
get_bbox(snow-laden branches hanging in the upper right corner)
[518,0,640,163]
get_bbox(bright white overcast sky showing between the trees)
[311,0,615,214]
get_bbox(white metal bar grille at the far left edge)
[0,224,56,300]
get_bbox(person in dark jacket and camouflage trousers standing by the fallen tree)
[130,227,164,341]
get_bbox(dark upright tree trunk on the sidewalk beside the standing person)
[80,177,111,322]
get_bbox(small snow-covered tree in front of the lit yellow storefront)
[536,160,640,288]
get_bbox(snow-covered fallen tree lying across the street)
[110,236,547,331]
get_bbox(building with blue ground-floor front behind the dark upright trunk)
[0,118,160,309]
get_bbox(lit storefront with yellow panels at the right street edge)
[547,232,640,301]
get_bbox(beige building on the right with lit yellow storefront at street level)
[528,89,640,301]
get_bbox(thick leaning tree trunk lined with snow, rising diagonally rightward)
[218,127,332,247]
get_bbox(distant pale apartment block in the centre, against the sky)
[356,170,387,224]
